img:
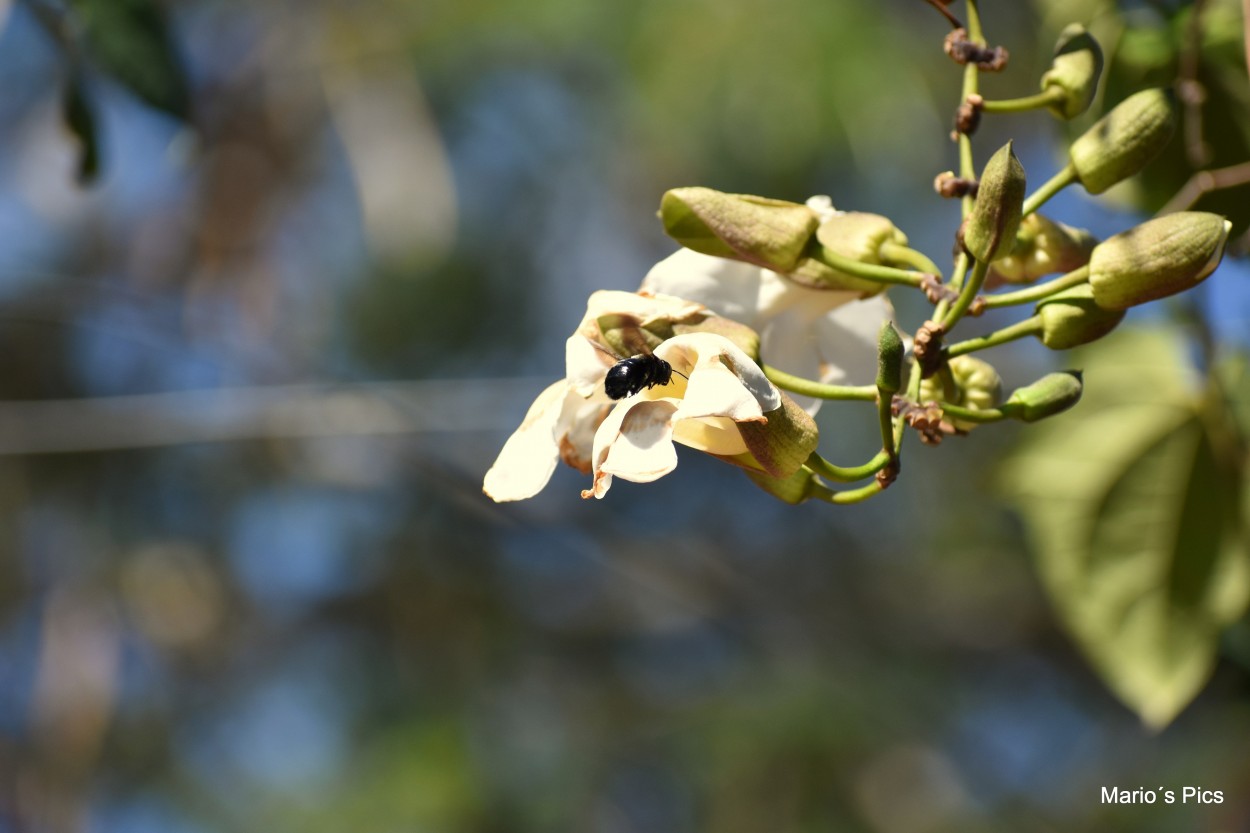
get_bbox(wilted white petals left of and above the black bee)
[483,291,708,502]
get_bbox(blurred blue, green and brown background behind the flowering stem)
[0,0,1250,833]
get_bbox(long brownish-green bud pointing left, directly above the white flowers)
[660,188,820,273]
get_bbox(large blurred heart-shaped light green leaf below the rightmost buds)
[1001,333,1250,728]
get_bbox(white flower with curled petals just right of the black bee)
[581,333,790,498]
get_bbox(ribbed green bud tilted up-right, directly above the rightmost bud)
[1068,89,1176,194]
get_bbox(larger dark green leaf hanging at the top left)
[70,0,190,120]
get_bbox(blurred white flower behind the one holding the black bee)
[643,249,894,414]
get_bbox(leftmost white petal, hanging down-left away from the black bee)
[481,379,569,502]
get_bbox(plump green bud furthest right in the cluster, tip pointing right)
[1090,211,1233,309]
